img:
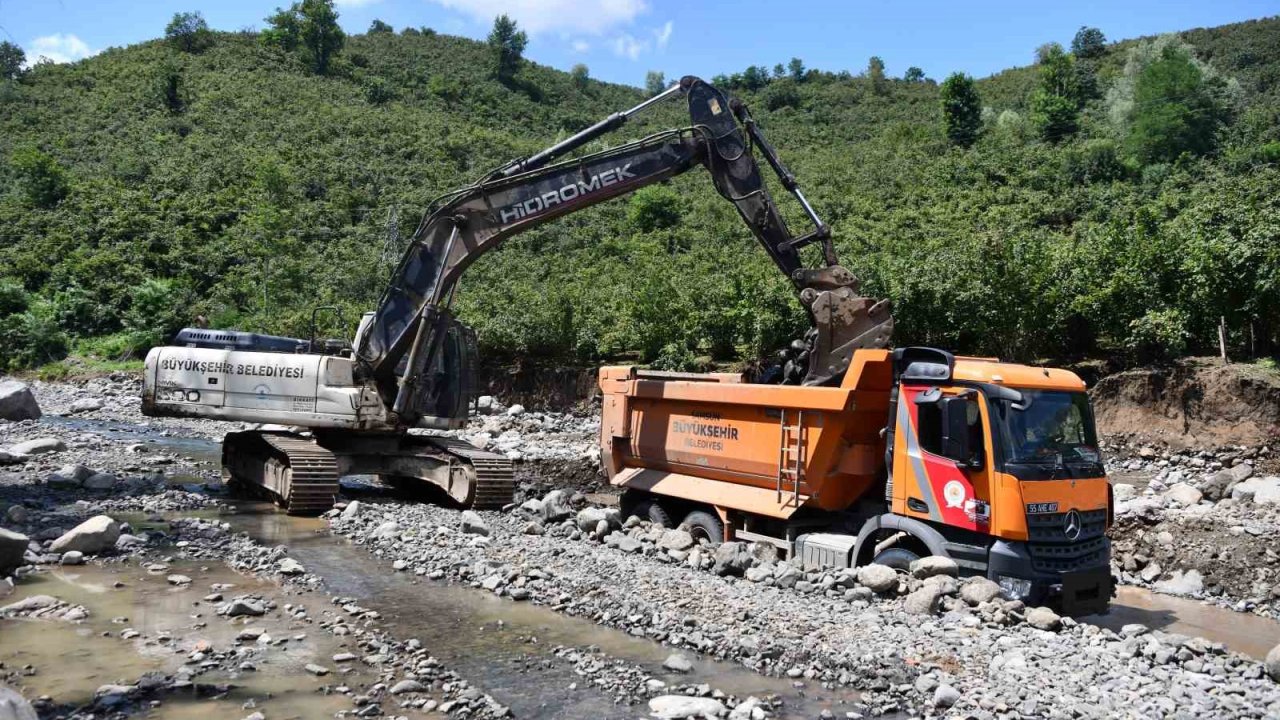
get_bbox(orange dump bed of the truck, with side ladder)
[600,350,893,519]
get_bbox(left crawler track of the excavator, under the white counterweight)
[223,432,338,515]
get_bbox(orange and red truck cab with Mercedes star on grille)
[886,348,1111,605]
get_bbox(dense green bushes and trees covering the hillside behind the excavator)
[0,7,1280,370]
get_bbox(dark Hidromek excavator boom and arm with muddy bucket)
[356,77,892,424]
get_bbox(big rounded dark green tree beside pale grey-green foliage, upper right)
[1128,45,1229,163]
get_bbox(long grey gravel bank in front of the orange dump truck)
[330,491,1280,717]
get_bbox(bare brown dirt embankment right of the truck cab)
[1091,359,1280,447]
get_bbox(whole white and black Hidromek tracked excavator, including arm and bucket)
[142,77,892,514]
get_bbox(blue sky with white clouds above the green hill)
[0,0,1280,85]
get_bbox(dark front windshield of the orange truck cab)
[996,389,1102,468]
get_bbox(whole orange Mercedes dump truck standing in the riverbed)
[600,347,1112,614]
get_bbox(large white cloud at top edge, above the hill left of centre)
[430,0,649,35]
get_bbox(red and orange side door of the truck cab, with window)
[891,383,993,533]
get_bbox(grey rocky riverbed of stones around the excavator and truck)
[0,375,1280,719]
